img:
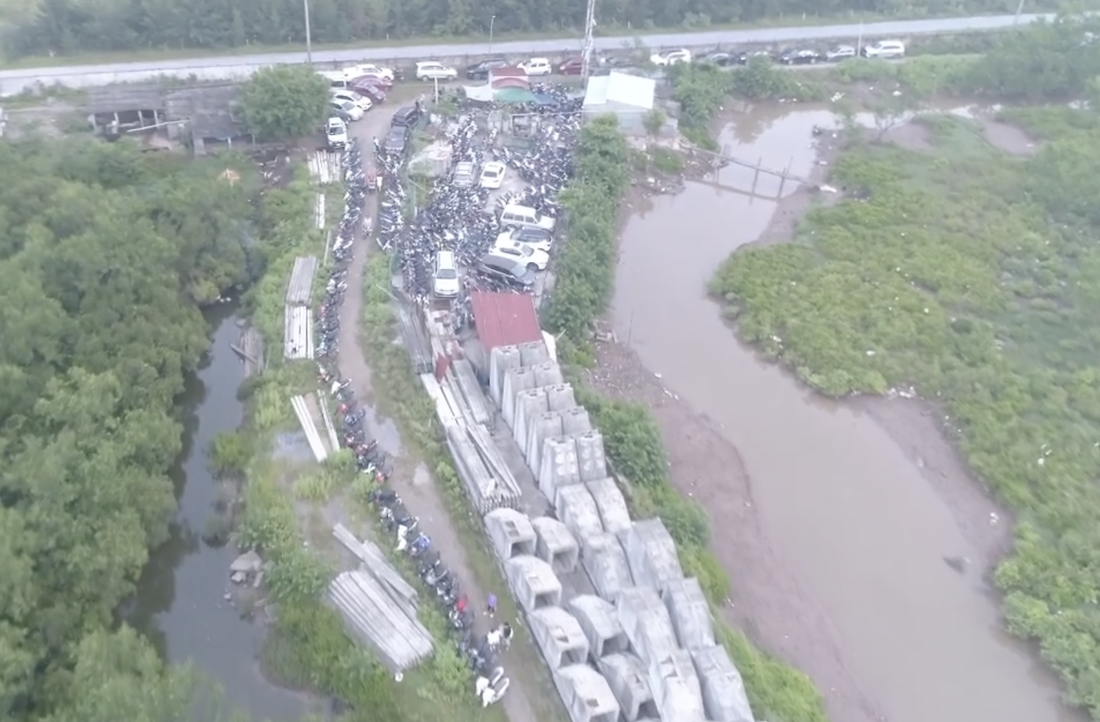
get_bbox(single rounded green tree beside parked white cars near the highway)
[241,65,329,139]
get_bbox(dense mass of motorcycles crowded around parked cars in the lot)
[378,86,581,305]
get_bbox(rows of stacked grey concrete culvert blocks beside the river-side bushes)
[485,343,754,722]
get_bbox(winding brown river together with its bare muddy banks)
[589,107,1074,722]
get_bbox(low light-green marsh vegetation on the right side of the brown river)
[712,21,1100,719]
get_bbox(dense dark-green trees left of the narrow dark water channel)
[0,140,264,722]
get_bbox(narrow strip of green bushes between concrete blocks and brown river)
[542,116,825,722]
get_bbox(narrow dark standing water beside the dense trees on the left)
[127,306,305,722]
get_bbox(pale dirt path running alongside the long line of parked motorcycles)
[337,108,536,722]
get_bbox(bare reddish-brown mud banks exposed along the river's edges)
[587,117,1025,722]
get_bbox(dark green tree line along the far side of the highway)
[3,0,1053,56]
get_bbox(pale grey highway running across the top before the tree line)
[0,14,1053,97]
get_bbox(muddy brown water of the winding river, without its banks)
[614,108,1084,722]
